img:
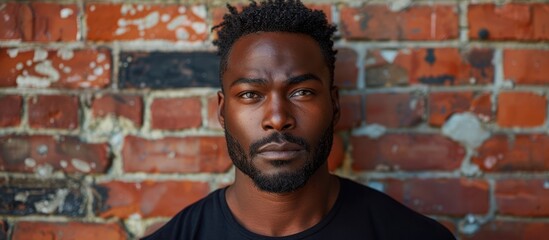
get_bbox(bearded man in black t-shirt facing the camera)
[146,0,454,239]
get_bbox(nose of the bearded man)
[261,96,296,131]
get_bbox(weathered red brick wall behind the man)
[0,0,549,240]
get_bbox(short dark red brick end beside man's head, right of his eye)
[334,48,358,89]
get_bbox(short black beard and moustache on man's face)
[225,125,334,193]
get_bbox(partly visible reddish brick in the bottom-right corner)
[461,220,549,240]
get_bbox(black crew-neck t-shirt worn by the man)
[144,178,455,240]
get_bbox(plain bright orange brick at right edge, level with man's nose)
[496,92,547,127]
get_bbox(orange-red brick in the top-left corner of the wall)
[0,2,78,42]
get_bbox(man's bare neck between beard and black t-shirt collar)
[226,164,339,237]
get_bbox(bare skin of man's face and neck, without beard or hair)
[218,32,339,236]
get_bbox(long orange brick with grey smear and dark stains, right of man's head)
[365,48,494,87]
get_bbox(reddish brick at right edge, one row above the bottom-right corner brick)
[495,179,549,217]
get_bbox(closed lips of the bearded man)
[257,142,305,160]
